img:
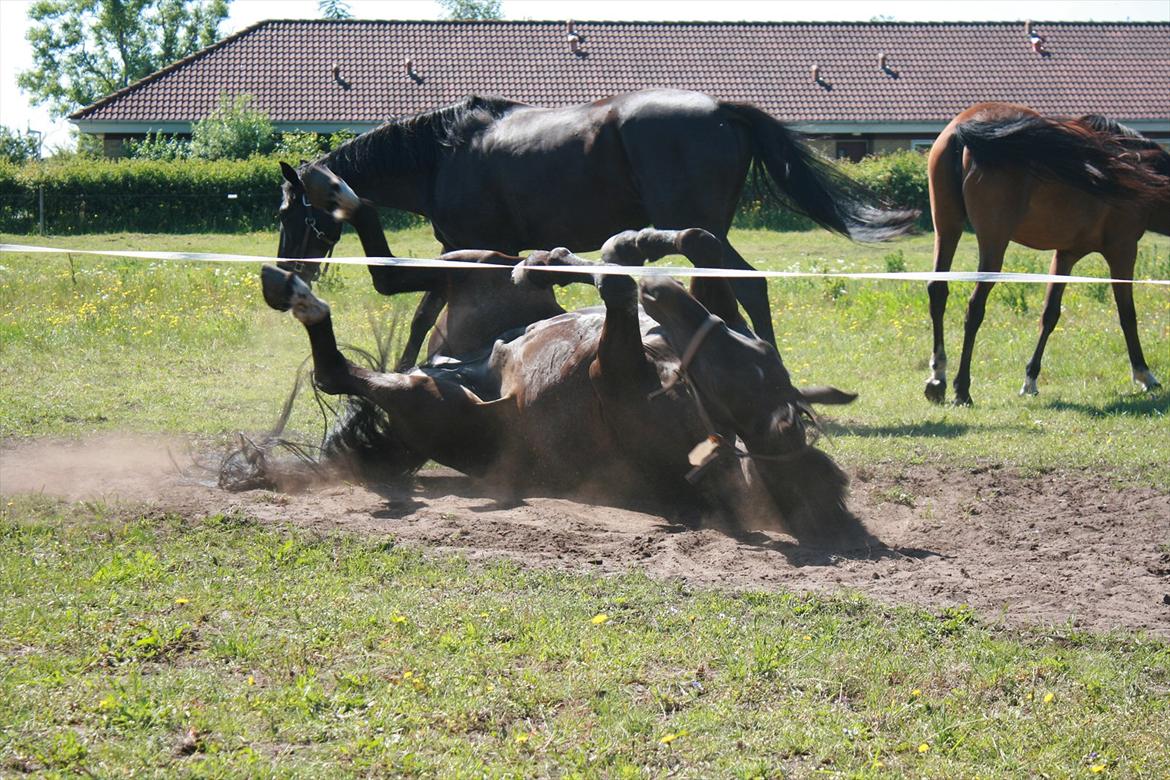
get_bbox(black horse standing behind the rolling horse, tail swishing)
[277,89,917,367]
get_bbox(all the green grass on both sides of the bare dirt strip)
[0,230,1170,778]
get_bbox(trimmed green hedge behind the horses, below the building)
[0,151,930,235]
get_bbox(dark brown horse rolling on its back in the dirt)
[262,166,863,541]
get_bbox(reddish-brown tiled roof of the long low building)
[70,21,1170,124]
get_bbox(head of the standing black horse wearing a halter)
[276,161,343,282]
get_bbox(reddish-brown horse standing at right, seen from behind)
[925,103,1170,405]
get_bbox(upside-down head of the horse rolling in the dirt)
[641,277,863,540]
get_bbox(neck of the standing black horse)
[318,124,434,218]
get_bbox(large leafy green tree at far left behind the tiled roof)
[16,0,230,117]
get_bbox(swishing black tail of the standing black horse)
[721,102,918,241]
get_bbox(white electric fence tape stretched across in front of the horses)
[0,243,1170,287]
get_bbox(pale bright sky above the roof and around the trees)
[0,0,1170,151]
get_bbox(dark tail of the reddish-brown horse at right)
[954,116,1170,200]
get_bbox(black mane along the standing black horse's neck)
[321,95,525,178]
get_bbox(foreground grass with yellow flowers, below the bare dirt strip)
[0,499,1170,778]
